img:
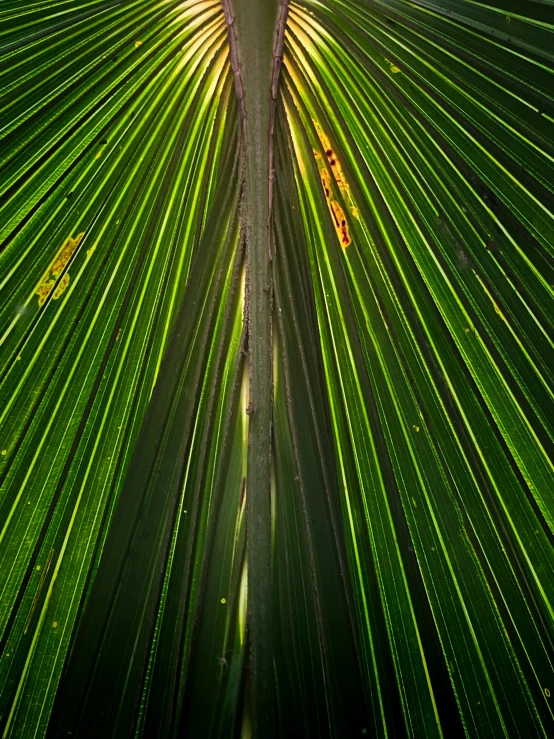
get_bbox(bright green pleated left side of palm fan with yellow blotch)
[2,3,239,735]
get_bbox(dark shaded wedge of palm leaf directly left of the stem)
[46,136,242,736]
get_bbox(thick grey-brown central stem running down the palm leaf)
[222,0,287,739]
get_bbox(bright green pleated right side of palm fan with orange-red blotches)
[287,3,552,736]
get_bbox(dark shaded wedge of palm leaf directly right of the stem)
[273,108,373,737]
